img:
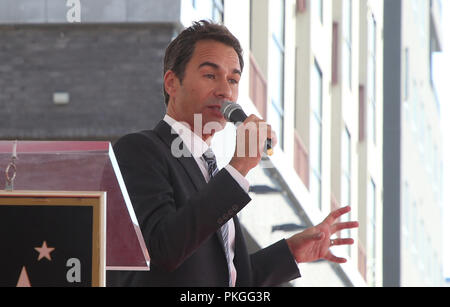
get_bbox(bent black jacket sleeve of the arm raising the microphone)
[114,134,251,271]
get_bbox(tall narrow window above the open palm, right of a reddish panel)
[309,62,323,208]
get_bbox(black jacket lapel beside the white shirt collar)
[154,120,206,190]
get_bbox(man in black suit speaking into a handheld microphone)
[108,21,358,287]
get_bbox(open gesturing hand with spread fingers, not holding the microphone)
[286,206,359,263]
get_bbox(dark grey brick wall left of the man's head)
[0,24,174,139]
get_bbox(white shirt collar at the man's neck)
[163,114,209,158]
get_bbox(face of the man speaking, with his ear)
[164,40,241,138]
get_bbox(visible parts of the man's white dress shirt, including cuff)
[164,114,250,287]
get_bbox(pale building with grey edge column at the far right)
[383,0,444,286]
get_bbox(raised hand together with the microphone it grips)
[220,101,276,176]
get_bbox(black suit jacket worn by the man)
[107,121,299,287]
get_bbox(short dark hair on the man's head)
[163,20,244,106]
